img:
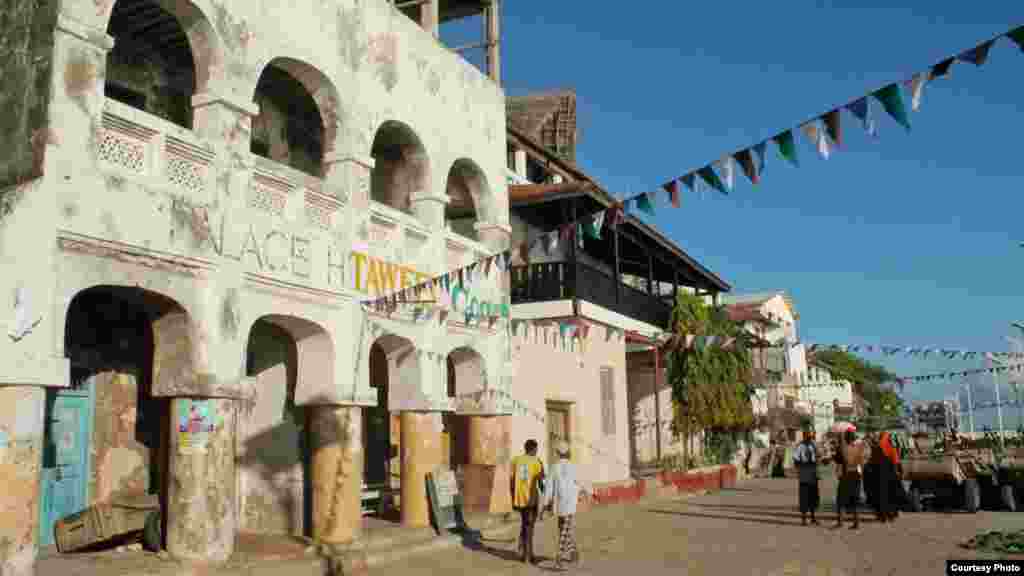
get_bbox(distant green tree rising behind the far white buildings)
[814,349,903,427]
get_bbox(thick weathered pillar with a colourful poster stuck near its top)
[167,398,238,563]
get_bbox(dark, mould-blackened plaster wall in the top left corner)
[0,0,59,187]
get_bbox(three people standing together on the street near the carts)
[794,424,905,530]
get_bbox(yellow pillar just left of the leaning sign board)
[400,412,441,527]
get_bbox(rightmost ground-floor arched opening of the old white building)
[442,346,486,476]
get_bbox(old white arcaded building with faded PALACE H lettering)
[0,0,510,576]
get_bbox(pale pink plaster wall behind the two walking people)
[511,317,630,484]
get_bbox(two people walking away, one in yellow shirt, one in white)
[511,440,580,569]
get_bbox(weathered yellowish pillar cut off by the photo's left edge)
[0,386,45,576]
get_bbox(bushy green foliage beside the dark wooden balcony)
[666,294,754,467]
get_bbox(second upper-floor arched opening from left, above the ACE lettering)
[250,58,330,177]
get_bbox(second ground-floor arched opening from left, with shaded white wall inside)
[238,316,334,536]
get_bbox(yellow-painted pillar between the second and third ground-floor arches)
[309,406,364,544]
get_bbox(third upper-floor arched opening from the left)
[370,121,430,214]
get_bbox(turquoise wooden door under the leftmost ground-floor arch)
[39,379,92,546]
